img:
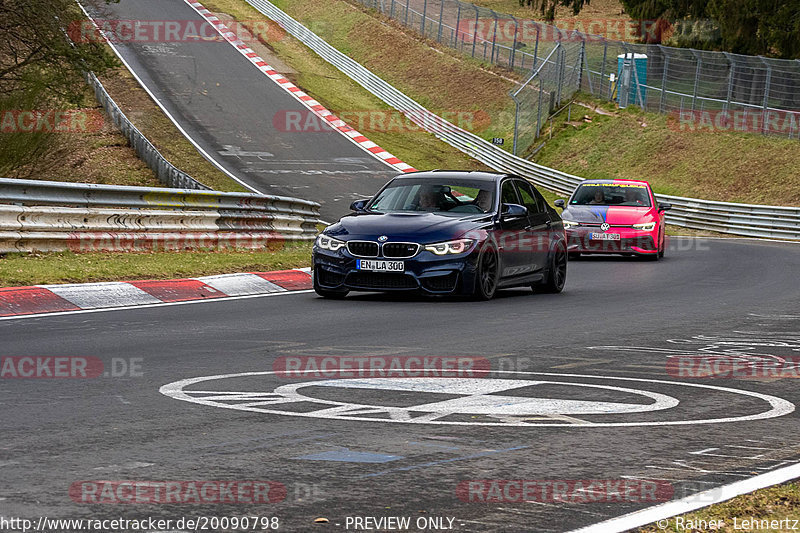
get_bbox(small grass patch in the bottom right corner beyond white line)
[639,482,800,533]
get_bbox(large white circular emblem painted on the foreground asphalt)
[159,371,795,427]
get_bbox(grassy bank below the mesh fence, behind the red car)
[535,94,800,205]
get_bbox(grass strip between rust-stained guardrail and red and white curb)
[0,242,312,287]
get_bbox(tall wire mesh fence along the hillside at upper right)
[359,0,800,151]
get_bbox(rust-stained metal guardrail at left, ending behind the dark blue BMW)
[0,179,320,253]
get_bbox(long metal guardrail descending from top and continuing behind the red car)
[247,0,800,240]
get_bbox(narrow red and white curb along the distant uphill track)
[184,0,417,172]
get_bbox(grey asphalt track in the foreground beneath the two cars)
[0,238,800,532]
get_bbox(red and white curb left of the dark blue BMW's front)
[0,268,311,317]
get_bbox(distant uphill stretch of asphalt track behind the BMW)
[85,0,399,220]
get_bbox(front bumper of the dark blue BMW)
[311,246,478,294]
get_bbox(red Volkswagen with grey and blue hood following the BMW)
[555,180,672,261]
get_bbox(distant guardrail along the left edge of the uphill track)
[86,72,210,190]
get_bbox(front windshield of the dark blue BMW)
[367,178,495,214]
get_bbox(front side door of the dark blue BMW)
[495,179,530,278]
